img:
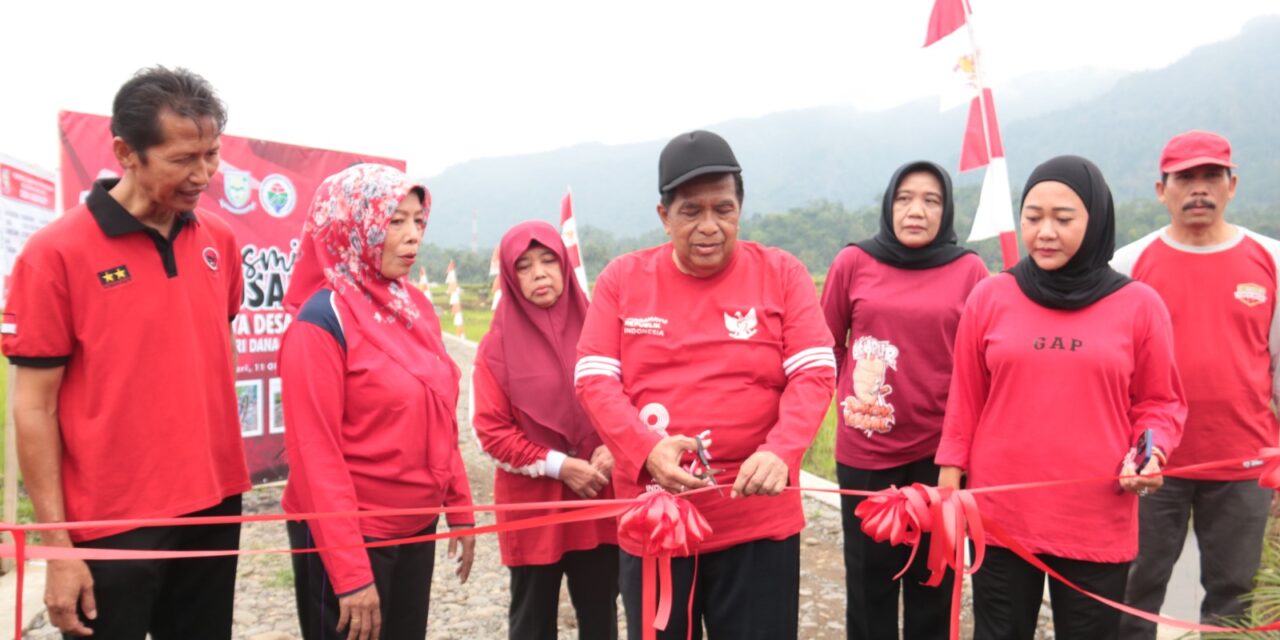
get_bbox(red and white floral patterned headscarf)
[284,164,458,404]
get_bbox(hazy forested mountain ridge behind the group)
[425,15,1280,247]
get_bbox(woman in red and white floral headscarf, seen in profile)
[280,164,474,640]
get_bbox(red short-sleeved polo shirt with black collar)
[3,183,250,541]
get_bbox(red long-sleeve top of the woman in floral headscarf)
[280,289,475,594]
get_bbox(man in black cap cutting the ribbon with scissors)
[573,131,836,639]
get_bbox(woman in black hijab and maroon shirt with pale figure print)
[822,161,987,639]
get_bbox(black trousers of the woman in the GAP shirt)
[973,545,1129,640]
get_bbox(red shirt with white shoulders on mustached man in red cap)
[1111,227,1280,480]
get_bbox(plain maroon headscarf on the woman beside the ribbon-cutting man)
[479,221,600,458]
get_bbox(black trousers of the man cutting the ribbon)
[621,534,800,640]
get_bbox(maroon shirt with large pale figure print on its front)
[822,247,988,470]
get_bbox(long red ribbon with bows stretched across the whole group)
[0,447,1280,640]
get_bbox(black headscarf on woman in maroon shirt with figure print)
[856,160,973,269]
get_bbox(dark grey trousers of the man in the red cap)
[1120,477,1274,640]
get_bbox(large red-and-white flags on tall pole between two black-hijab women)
[924,0,1018,269]
